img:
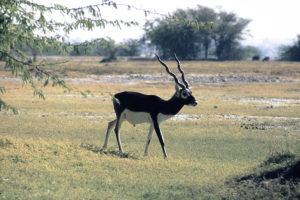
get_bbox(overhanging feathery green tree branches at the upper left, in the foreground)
[0,0,140,113]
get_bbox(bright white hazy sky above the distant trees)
[34,0,300,45]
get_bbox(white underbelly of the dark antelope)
[121,109,174,125]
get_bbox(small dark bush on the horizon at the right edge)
[280,35,300,61]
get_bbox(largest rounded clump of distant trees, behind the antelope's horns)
[145,6,250,60]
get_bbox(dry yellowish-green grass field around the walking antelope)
[0,57,300,199]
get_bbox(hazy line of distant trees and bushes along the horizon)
[12,6,290,61]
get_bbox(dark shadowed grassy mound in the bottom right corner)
[228,152,300,199]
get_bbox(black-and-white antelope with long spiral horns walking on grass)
[103,55,198,158]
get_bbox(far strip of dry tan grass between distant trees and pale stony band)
[0,57,300,79]
